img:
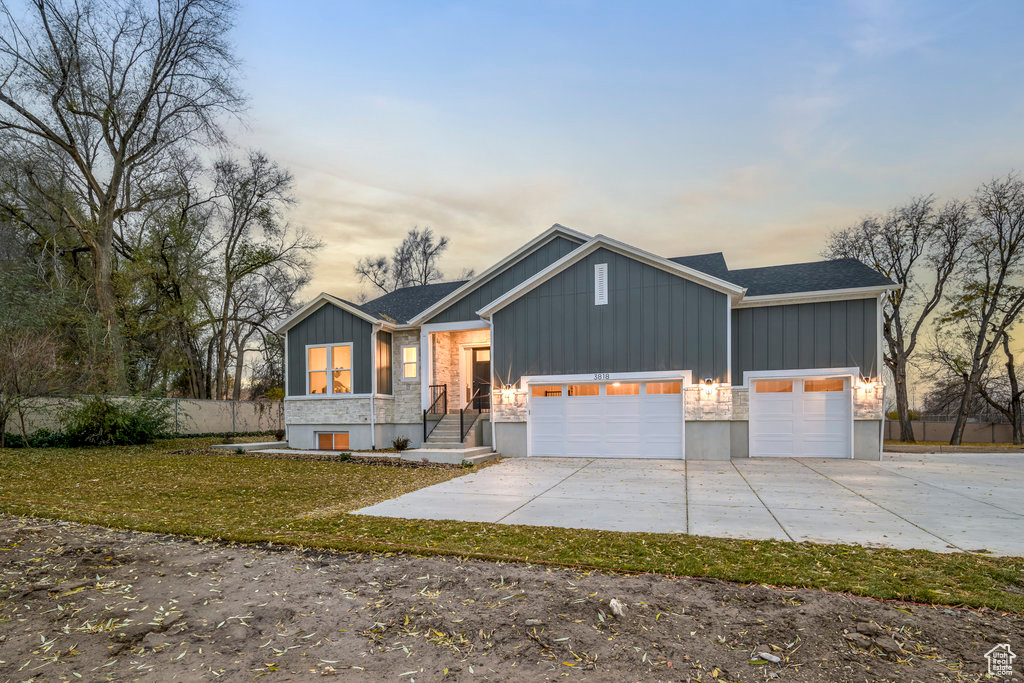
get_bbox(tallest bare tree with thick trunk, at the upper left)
[0,0,242,390]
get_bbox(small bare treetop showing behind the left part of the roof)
[355,226,449,294]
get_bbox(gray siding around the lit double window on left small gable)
[288,303,373,396]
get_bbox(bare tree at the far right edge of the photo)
[936,173,1024,444]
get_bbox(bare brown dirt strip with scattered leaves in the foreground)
[0,517,1024,682]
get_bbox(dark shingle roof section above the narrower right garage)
[726,258,893,296]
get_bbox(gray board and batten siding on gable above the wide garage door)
[490,249,728,384]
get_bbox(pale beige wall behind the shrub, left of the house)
[7,397,285,434]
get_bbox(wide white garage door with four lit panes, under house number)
[527,380,683,458]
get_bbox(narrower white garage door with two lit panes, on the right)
[750,377,853,458]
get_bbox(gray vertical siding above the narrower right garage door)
[732,299,879,385]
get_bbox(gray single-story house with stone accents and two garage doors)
[279,224,895,460]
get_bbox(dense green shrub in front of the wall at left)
[63,396,173,445]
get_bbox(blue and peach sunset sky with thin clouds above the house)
[232,0,1024,297]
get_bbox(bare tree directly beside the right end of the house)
[824,197,971,442]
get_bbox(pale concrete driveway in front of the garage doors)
[357,454,1024,556]
